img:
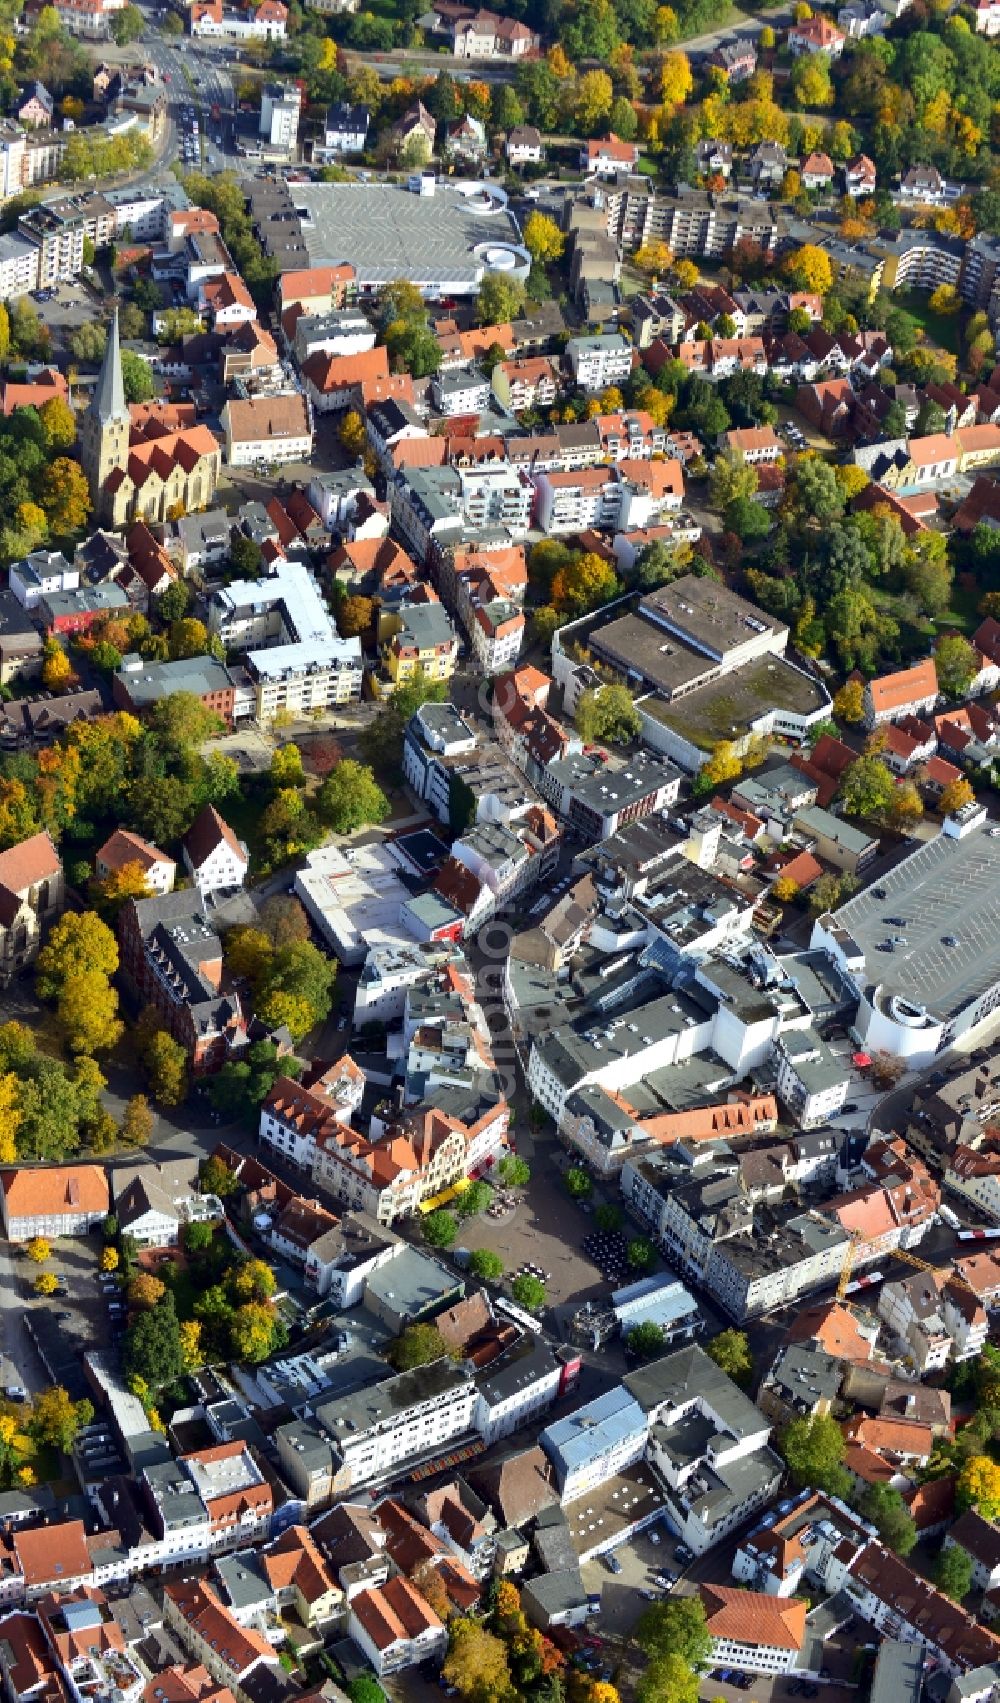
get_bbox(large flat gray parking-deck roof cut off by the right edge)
[835,829,1000,1018]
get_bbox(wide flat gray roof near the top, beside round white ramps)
[290,184,520,291]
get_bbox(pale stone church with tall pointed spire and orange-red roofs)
[80,307,221,526]
